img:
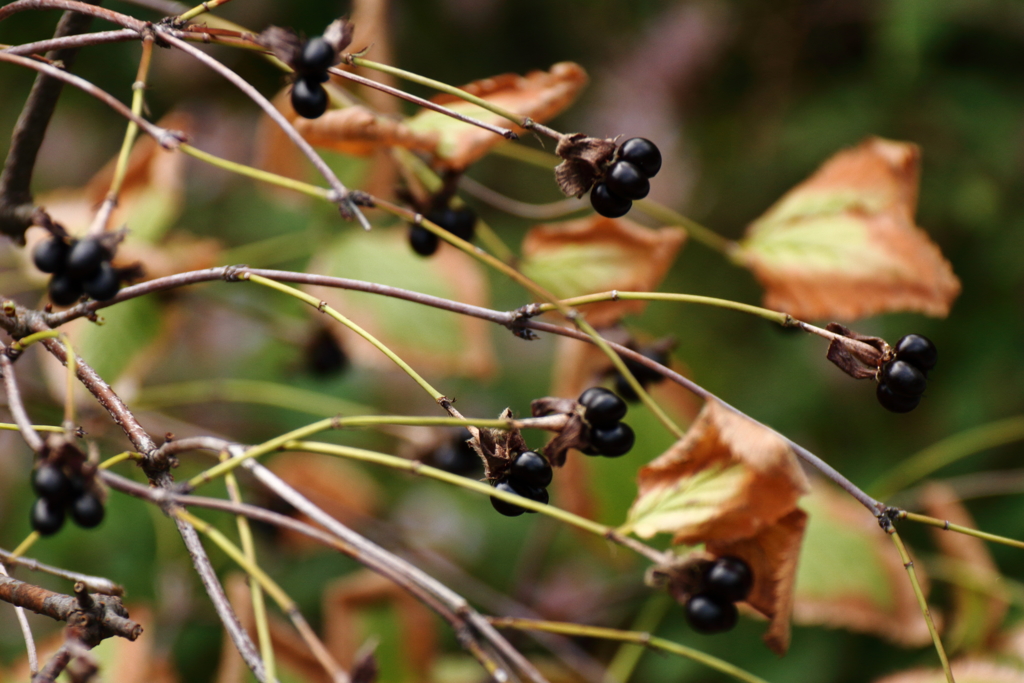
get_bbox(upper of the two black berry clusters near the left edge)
[32,236,121,306]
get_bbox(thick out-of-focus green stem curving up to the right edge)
[868,416,1024,501]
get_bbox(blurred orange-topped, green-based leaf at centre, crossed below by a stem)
[522,216,686,327]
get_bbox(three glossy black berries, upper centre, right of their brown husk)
[590,137,662,218]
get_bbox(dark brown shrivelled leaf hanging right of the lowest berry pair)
[706,509,807,654]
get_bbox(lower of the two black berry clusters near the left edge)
[31,463,103,536]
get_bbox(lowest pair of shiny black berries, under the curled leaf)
[686,557,754,634]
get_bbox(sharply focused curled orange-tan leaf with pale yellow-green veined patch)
[629,400,810,545]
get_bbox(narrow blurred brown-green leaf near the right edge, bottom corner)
[920,482,1010,649]
